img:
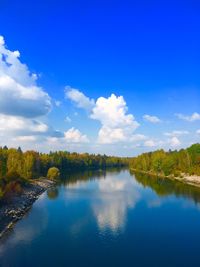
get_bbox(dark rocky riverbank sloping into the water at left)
[0,179,54,238]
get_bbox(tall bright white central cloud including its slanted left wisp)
[66,88,142,144]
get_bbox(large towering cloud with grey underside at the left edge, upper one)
[0,36,51,118]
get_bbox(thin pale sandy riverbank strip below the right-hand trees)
[130,169,200,187]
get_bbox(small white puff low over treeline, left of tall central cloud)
[64,127,89,143]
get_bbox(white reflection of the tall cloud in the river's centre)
[93,175,140,232]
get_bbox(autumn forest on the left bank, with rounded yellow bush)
[0,146,128,199]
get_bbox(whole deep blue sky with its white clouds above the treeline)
[0,0,200,156]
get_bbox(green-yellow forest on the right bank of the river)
[130,144,200,177]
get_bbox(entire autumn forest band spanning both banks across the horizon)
[0,144,200,199]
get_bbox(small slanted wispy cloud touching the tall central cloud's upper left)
[65,86,95,111]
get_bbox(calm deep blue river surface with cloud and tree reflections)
[0,170,200,267]
